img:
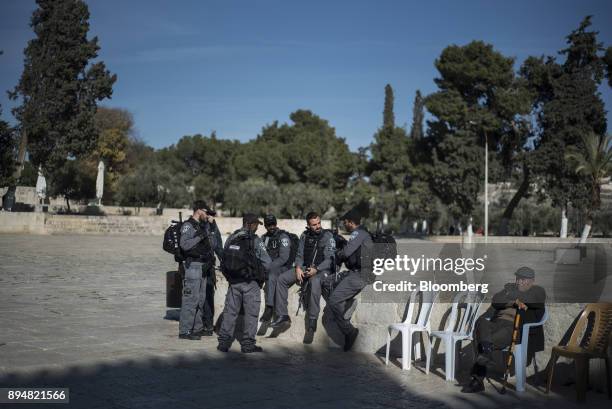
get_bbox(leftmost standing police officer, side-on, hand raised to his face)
[179,200,214,340]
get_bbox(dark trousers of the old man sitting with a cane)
[472,317,514,377]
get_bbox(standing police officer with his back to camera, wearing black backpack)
[217,213,272,353]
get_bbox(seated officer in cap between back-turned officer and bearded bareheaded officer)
[259,214,291,323]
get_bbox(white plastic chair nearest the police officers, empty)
[385,291,438,370]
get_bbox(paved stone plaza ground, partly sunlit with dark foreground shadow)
[0,235,609,409]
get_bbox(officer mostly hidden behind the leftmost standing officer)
[202,211,223,337]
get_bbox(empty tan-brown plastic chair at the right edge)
[546,303,612,401]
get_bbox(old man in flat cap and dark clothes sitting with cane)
[462,267,546,393]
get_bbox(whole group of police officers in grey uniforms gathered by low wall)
[179,201,372,353]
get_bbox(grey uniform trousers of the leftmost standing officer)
[179,262,208,334]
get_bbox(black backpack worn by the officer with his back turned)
[221,232,265,283]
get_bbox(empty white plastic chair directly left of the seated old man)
[425,291,483,381]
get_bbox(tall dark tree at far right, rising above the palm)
[522,16,607,236]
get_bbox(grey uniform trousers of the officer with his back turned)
[219,281,261,347]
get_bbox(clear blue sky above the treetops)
[0,0,612,149]
